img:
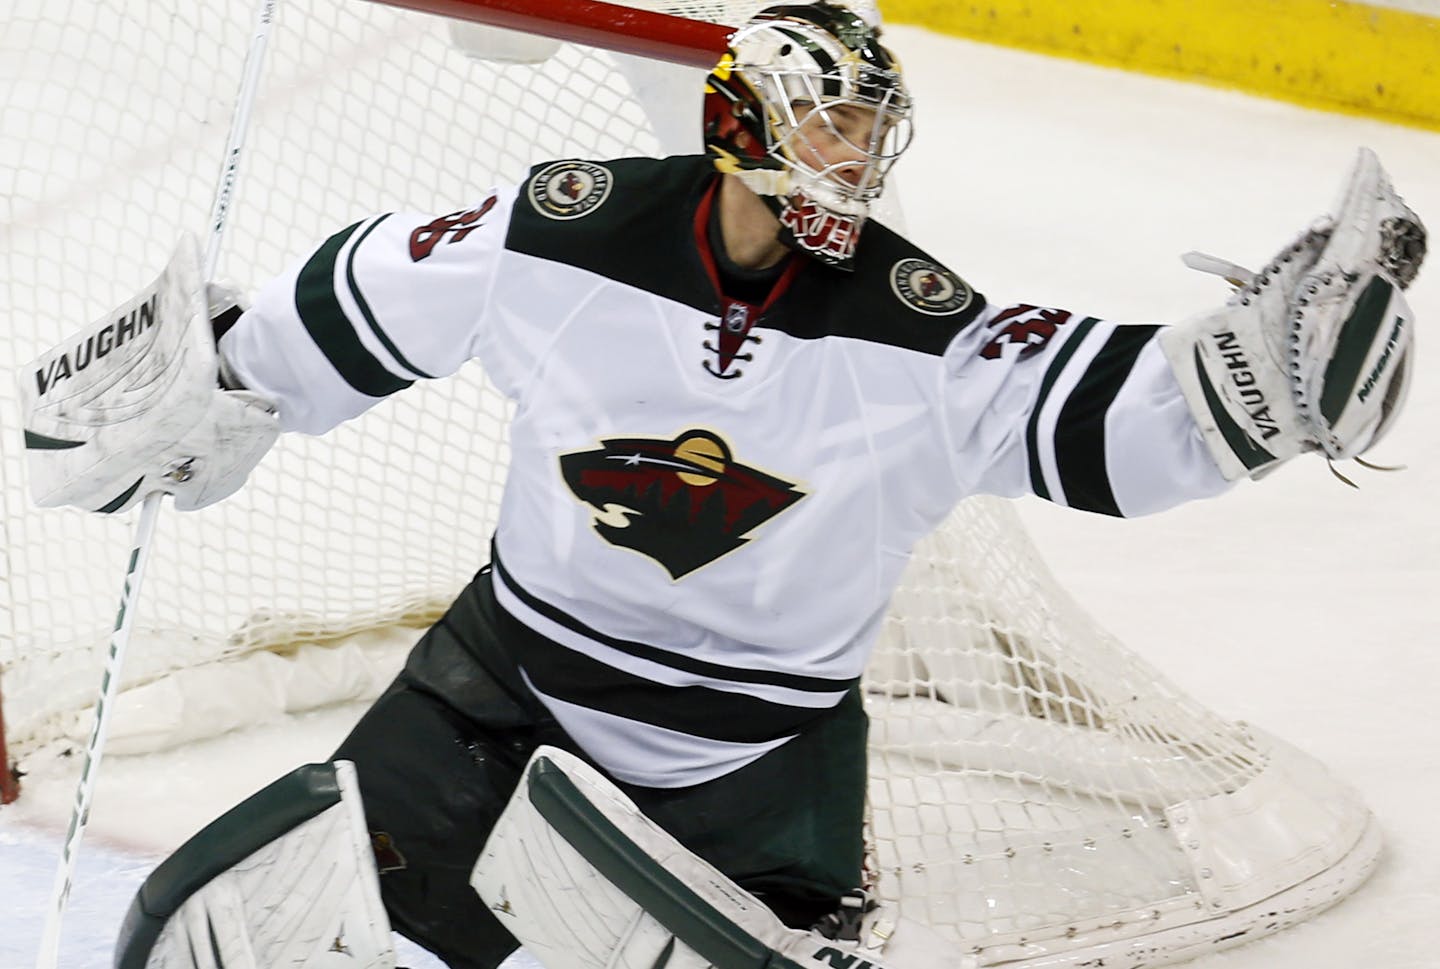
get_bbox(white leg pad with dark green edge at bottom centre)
[471,747,959,969]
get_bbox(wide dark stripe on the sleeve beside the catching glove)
[1054,325,1159,517]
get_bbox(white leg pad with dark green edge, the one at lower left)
[115,760,395,969]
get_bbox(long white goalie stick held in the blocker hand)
[35,0,275,969]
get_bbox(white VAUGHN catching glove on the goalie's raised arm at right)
[1161,148,1426,481]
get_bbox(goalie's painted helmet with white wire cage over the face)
[704,3,912,268]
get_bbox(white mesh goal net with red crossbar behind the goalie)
[0,0,1380,969]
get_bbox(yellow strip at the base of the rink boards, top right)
[880,0,1440,130]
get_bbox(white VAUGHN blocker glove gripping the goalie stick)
[20,236,279,513]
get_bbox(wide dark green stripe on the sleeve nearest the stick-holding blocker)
[295,222,415,397]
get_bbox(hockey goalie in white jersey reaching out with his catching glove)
[23,3,1426,969]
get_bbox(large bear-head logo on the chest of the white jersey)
[560,431,805,579]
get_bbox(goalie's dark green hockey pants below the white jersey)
[334,569,865,969]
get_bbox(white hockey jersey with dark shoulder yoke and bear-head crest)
[220,157,1225,786]
